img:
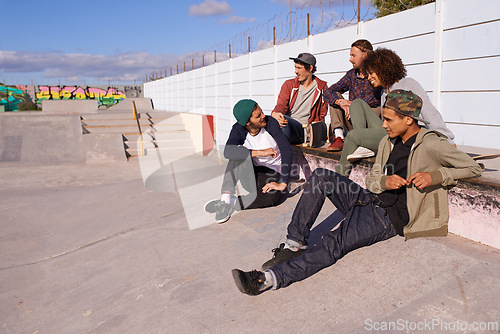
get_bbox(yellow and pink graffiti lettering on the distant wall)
[36,86,125,106]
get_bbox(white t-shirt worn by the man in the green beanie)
[243,128,281,173]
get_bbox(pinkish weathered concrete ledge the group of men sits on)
[292,146,500,249]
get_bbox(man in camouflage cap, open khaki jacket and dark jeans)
[232,90,481,295]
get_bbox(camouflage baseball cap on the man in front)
[384,89,429,124]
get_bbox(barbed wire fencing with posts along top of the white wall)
[145,0,376,82]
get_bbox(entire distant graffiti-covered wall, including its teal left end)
[0,84,142,111]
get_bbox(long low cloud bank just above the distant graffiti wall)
[0,51,179,83]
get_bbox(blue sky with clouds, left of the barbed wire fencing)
[0,0,368,85]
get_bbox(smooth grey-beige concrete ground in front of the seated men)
[0,155,500,334]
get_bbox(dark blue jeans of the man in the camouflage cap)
[271,168,396,288]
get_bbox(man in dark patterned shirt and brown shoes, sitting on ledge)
[323,39,381,151]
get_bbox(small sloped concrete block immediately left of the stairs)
[83,133,127,162]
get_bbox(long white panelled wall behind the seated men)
[144,0,500,149]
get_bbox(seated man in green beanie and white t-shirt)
[205,99,293,223]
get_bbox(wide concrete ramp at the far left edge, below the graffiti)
[0,112,85,165]
